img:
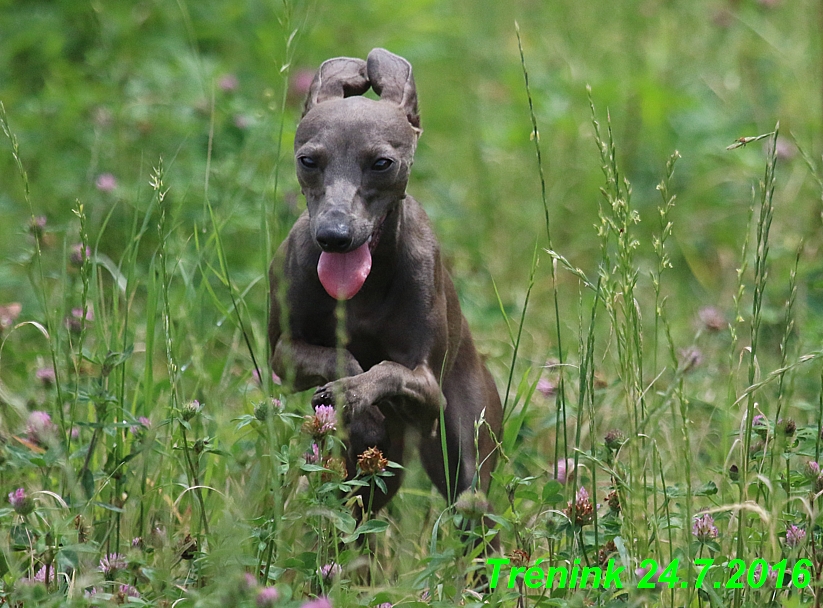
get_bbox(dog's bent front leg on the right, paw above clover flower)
[312,361,446,423]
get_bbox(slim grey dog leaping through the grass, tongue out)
[269,49,502,511]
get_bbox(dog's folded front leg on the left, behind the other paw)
[272,336,363,391]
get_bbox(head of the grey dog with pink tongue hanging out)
[294,49,421,299]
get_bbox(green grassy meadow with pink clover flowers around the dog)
[0,0,823,608]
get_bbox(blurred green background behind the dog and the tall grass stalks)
[0,0,823,381]
